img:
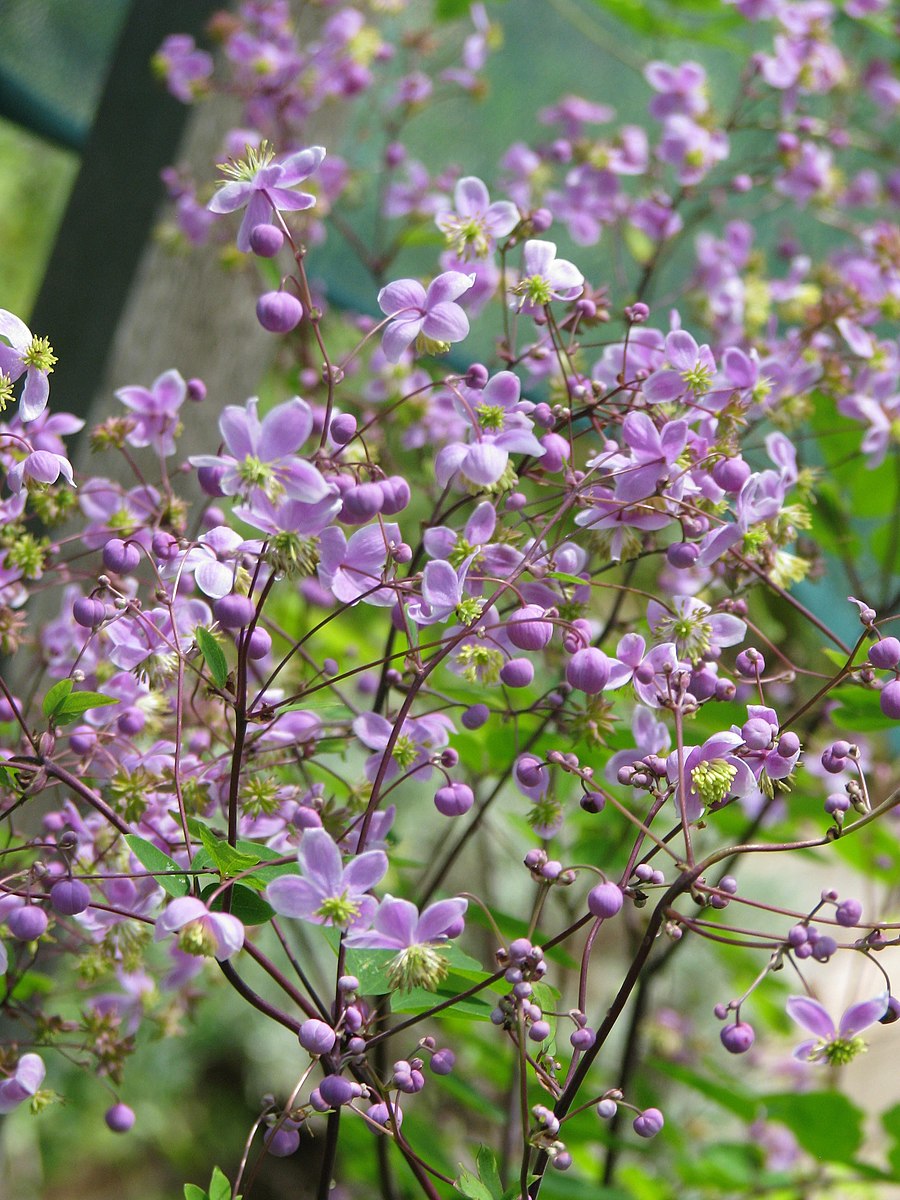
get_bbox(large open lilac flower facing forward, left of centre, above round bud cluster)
[190,396,334,504]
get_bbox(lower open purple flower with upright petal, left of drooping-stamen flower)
[265,829,388,928]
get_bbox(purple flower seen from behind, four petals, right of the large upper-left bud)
[378,271,475,362]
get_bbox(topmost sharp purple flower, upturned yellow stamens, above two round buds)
[208,142,325,253]
